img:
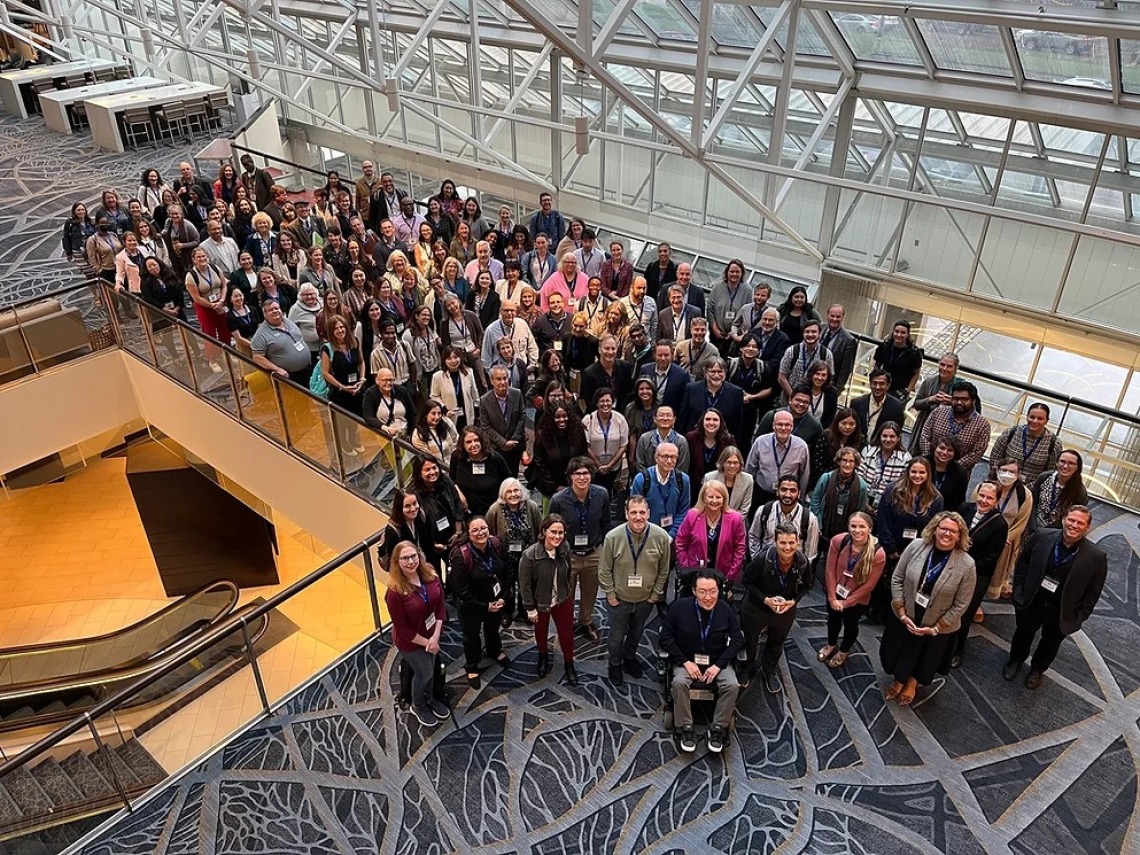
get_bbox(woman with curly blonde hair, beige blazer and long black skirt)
[879,511,976,707]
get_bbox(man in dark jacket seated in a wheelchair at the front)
[659,569,744,752]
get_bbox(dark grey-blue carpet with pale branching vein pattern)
[0,120,1140,855]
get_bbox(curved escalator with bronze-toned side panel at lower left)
[0,580,238,733]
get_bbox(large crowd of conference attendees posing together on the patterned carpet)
[63,154,1106,751]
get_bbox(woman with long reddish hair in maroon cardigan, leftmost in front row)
[384,540,450,727]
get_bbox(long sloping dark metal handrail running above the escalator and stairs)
[0,532,383,780]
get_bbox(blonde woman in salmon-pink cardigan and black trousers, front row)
[815,511,887,668]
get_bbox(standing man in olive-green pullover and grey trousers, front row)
[597,496,673,686]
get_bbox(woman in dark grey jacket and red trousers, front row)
[519,514,578,686]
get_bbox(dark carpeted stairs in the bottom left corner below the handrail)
[0,738,166,855]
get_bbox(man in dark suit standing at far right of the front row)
[1001,505,1108,689]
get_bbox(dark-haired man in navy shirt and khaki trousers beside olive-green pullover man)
[551,457,611,642]
